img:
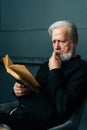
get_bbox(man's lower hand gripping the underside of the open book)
[13,82,29,97]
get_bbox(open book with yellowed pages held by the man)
[3,55,40,93]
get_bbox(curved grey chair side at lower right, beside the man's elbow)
[48,99,86,130]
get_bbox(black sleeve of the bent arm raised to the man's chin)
[47,64,87,115]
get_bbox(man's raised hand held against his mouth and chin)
[48,52,61,70]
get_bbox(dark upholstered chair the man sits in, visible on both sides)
[0,98,87,130]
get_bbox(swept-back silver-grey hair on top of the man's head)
[48,20,78,42]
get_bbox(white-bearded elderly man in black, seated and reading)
[0,20,87,130]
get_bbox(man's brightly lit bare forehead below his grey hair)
[52,26,68,38]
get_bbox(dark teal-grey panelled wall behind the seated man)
[0,0,87,130]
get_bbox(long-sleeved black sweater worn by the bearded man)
[15,56,87,127]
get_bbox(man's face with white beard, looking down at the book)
[52,26,75,60]
